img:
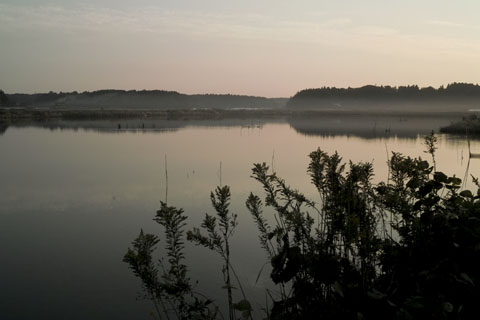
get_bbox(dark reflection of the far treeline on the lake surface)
[0,114,464,139]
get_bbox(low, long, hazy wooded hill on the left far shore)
[6,90,288,110]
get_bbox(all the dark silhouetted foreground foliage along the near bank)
[125,134,480,319]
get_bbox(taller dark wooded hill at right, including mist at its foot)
[287,83,480,111]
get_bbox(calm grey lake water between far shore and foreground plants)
[0,119,480,319]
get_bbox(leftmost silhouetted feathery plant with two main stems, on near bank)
[123,202,217,319]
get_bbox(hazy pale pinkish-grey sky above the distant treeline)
[0,0,480,96]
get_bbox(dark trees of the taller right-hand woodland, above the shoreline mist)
[287,83,480,108]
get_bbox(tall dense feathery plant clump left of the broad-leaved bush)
[247,150,379,319]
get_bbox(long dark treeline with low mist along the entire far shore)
[0,83,480,112]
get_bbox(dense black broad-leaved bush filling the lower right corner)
[377,144,480,319]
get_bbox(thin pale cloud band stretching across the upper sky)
[0,4,480,61]
